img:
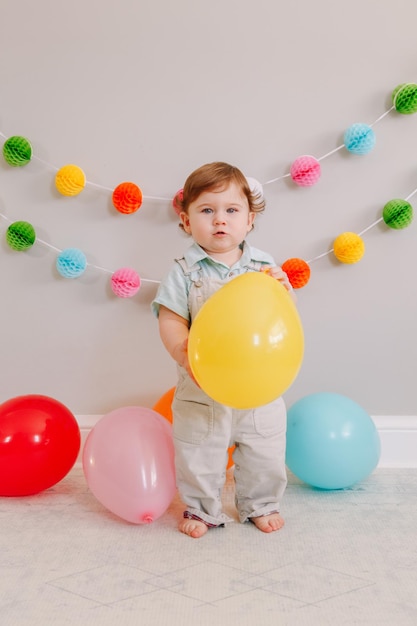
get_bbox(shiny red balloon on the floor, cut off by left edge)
[0,394,81,496]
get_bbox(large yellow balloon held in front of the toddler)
[188,272,304,409]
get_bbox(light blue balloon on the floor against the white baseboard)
[286,393,381,489]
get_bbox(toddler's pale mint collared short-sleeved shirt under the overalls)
[151,241,276,321]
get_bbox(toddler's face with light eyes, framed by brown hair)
[180,183,255,258]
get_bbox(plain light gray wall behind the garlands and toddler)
[0,0,417,415]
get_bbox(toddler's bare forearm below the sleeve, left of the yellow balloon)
[158,305,194,379]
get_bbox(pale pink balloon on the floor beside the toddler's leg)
[83,406,175,524]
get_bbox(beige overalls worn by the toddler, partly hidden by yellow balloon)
[172,259,287,526]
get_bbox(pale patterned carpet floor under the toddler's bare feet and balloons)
[0,467,417,626]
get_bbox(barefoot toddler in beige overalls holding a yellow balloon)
[152,162,291,538]
